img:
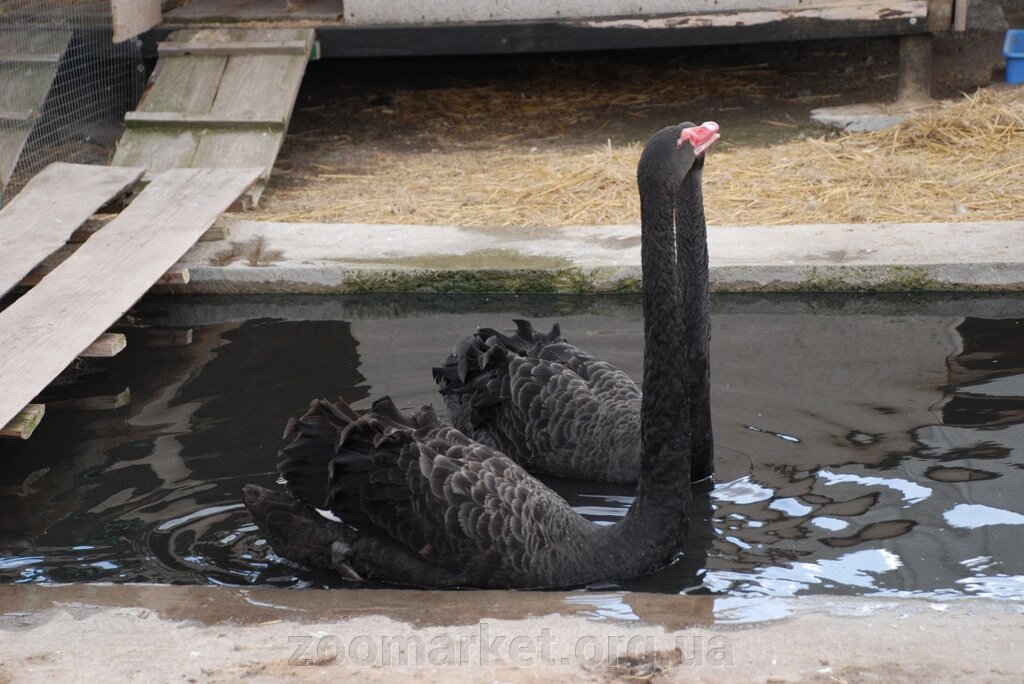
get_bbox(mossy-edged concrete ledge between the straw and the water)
[178,218,1024,293]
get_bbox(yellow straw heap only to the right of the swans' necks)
[706,89,1024,225]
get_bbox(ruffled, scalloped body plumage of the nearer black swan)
[254,398,591,586]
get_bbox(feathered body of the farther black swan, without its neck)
[434,319,640,482]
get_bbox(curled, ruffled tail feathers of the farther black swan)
[433,319,564,423]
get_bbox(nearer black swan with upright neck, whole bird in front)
[239,124,717,588]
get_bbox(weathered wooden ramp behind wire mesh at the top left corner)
[0,27,72,194]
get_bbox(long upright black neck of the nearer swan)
[614,172,690,551]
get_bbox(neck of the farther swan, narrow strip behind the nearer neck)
[675,168,715,481]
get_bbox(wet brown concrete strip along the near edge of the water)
[0,584,720,630]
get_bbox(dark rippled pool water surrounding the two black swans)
[0,296,1024,598]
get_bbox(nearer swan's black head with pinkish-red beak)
[637,121,721,187]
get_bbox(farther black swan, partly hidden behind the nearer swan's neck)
[433,122,718,482]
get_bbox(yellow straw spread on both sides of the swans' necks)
[253,88,1024,226]
